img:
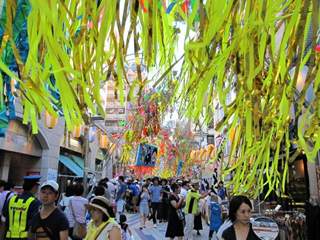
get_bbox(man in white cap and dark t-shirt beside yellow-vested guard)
[30,180,69,240]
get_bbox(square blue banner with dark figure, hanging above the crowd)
[136,143,158,167]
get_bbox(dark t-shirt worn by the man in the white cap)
[31,208,69,240]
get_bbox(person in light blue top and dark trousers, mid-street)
[149,177,162,227]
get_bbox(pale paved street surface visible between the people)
[126,213,209,240]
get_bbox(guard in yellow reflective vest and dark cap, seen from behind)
[3,175,41,239]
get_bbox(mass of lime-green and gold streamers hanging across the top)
[0,0,320,196]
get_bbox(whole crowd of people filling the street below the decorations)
[0,176,259,240]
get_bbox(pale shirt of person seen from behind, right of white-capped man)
[65,196,89,228]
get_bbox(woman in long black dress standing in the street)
[165,183,184,240]
